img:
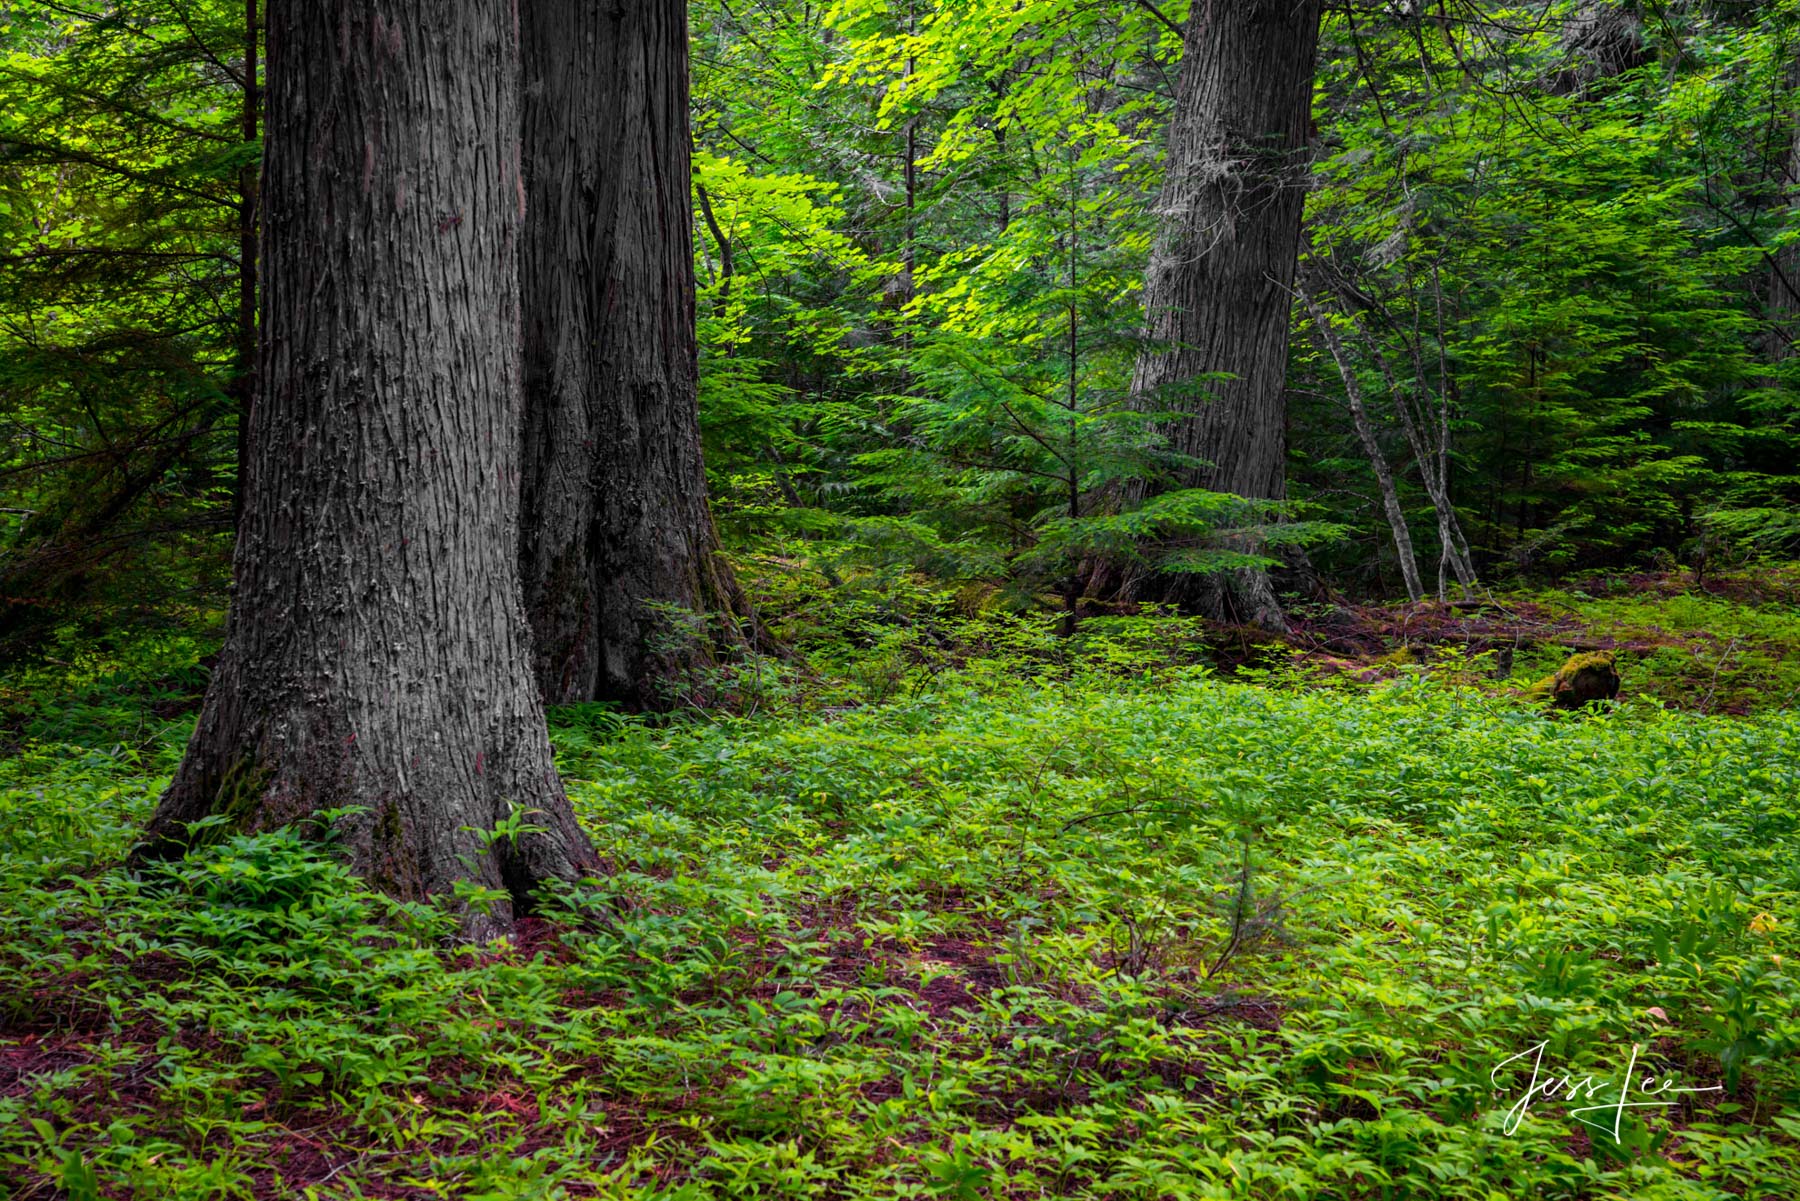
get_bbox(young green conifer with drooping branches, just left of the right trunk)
[855,148,1319,605]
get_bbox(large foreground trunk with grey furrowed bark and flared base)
[140,0,596,935]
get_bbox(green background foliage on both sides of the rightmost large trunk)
[680,0,1800,596]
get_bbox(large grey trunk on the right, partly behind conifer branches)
[1132,0,1319,627]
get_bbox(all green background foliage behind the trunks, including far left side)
[10,0,1800,637]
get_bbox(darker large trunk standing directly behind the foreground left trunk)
[520,0,749,706]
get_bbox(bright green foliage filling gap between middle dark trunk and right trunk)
[700,4,1327,605]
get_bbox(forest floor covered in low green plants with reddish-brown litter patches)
[0,578,1800,1201]
